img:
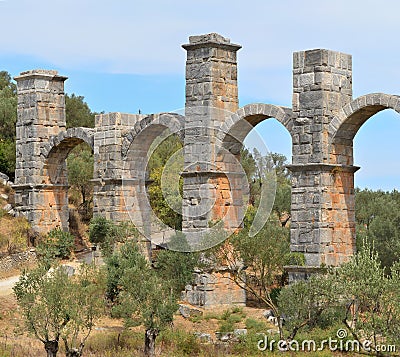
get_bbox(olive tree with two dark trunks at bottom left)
[13,264,104,357]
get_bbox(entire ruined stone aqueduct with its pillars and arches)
[14,34,400,277]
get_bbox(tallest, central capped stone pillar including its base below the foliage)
[182,34,246,308]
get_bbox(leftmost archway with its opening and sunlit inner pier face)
[42,129,93,245]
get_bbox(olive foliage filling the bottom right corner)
[338,242,400,345]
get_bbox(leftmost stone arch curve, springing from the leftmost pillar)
[41,128,94,185]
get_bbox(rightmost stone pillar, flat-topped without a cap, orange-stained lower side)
[290,49,356,279]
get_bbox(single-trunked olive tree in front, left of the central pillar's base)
[108,241,178,356]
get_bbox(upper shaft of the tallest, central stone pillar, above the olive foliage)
[182,33,241,233]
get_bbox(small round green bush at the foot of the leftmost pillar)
[36,228,74,264]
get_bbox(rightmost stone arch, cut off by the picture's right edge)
[329,93,400,165]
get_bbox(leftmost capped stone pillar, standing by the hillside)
[14,70,69,233]
